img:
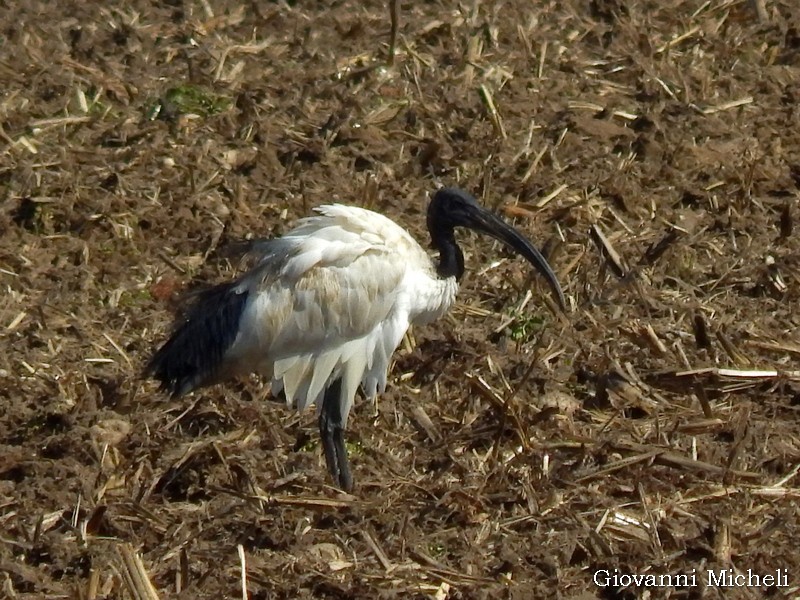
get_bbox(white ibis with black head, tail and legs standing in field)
[145,187,566,492]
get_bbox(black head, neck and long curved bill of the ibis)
[428,188,566,309]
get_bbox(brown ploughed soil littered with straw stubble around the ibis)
[0,0,800,599]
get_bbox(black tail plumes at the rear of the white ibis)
[144,282,248,398]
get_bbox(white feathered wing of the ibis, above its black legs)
[225,206,416,420]
